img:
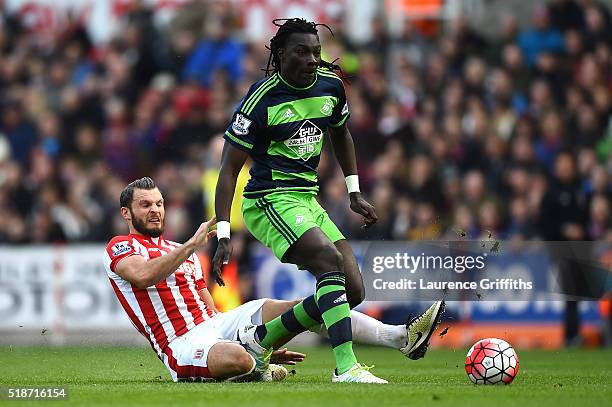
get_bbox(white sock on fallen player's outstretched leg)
[311,310,406,349]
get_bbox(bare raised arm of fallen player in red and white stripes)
[115,218,217,288]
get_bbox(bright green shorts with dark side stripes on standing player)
[242,192,344,261]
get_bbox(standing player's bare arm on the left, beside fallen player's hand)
[213,141,248,286]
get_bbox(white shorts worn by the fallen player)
[164,298,267,382]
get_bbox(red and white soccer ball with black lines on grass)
[465,338,518,384]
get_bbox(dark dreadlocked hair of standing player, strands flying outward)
[264,18,348,80]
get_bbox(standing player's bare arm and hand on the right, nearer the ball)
[329,124,378,227]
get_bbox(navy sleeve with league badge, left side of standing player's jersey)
[223,84,261,153]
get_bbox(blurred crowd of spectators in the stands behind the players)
[0,0,612,252]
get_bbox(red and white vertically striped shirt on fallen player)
[104,234,215,358]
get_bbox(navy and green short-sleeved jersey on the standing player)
[224,68,349,198]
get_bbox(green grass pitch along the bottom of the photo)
[0,347,612,407]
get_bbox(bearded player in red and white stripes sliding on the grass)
[104,177,304,381]
